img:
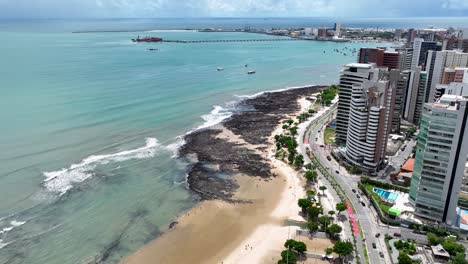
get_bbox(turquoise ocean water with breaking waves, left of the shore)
[0,19,394,264]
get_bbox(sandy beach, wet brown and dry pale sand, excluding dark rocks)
[123,85,326,264]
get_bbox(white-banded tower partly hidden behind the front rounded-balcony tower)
[336,63,379,145]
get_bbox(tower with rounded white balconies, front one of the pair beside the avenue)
[346,80,395,172]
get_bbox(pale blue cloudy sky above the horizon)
[0,0,468,18]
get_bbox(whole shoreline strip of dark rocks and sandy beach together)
[122,86,325,264]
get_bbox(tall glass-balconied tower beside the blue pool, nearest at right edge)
[410,95,468,225]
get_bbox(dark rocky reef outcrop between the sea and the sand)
[180,86,325,202]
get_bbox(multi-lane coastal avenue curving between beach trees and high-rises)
[299,104,391,264]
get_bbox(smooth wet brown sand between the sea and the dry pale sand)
[124,176,286,264]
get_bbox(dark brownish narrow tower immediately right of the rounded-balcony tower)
[388,70,410,133]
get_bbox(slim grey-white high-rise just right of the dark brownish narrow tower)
[403,67,427,125]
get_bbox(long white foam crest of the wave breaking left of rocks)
[43,138,159,195]
